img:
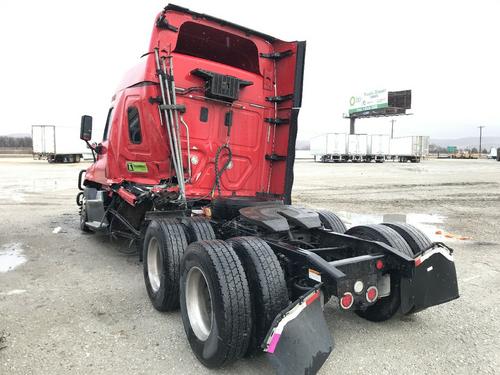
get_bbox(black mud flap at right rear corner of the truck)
[401,243,459,314]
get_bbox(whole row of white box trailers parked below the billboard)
[310,133,429,163]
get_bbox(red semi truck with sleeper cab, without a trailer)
[77,5,458,374]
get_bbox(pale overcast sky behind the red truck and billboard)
[0,0,500,139]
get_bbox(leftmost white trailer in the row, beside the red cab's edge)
[310,133,347,162]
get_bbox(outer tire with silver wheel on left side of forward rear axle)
[143,219,187,311]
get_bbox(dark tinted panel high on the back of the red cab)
[174,22,260,74]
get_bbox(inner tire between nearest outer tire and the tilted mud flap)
[228,237,289,354]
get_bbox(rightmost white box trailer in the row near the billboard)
[389,135,429,163]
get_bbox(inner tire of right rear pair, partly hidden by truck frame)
[346,224,413,322]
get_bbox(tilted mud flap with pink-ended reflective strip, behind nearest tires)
[262,286,333,375]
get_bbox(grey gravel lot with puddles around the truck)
[0,158,500,375]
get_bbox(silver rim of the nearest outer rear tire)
[186,267,213,341]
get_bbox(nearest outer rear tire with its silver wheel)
[180,240,252,368]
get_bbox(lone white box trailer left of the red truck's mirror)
[31,125,86,163]
